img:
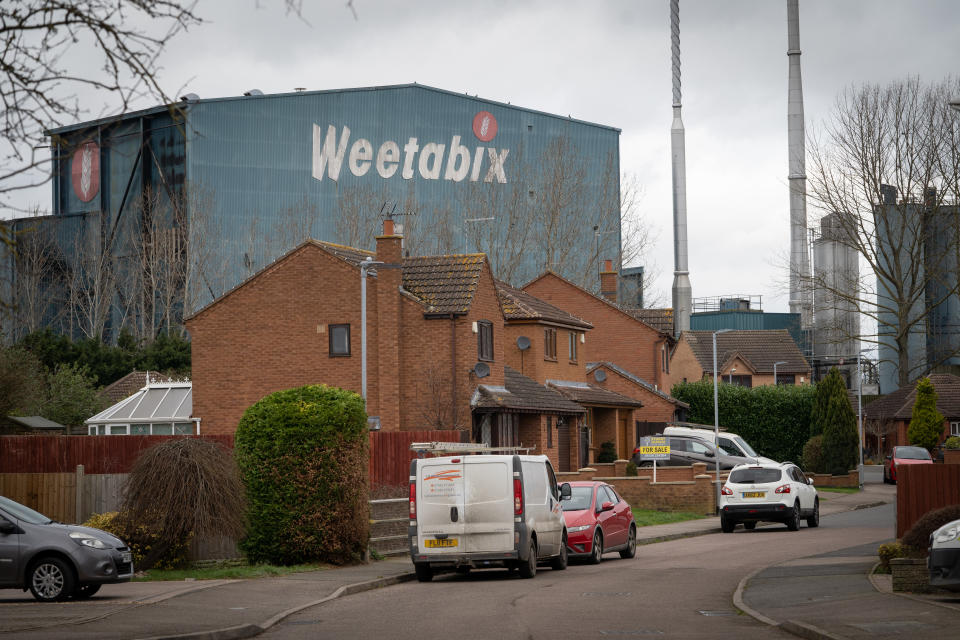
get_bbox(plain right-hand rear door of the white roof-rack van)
[463,456,514,552]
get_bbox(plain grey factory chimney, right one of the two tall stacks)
[787,0,813,329]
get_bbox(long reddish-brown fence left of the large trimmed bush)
[0,435,233,474]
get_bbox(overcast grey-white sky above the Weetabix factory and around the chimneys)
[7,0,960,311]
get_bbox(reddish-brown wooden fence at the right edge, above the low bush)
[897,464,960,538]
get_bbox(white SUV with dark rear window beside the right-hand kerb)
[720,462,820,533]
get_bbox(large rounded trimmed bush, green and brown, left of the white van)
[235,385,370,565]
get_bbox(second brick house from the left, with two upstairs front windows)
[497,282,642,470]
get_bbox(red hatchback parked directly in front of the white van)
[560,481,637,564]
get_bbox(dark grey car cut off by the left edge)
[0,496,133,602]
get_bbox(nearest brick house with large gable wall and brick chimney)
[186,220,582,458]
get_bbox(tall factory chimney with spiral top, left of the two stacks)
[670,0,693,336]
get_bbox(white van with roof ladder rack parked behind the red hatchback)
[410,443,570,582]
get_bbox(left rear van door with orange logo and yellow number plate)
[417,458,465,554]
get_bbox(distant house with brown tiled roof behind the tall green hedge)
[665,329,811,388]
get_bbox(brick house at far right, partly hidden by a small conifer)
[854,373,960,455]
